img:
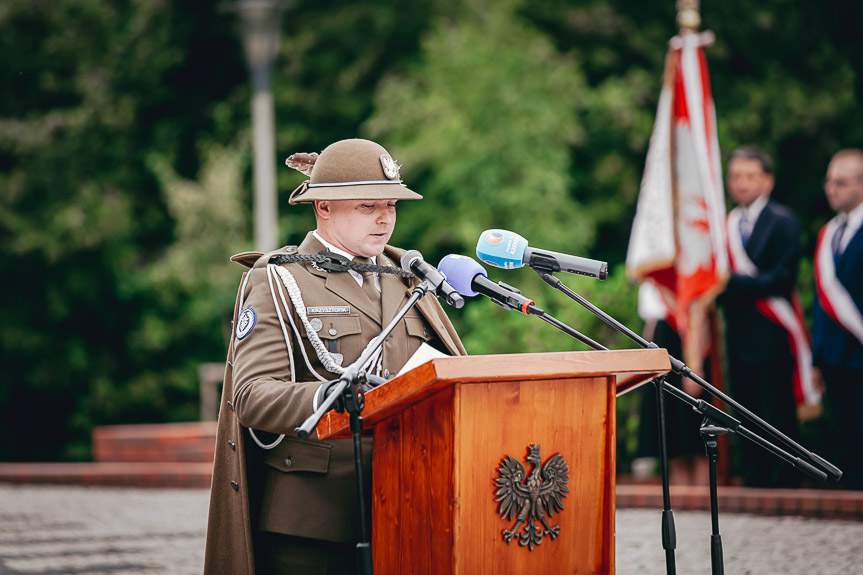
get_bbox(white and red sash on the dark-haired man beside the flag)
[726,210,820,405]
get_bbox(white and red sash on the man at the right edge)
[815,217,863,345]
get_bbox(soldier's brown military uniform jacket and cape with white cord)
[204,233,466,574]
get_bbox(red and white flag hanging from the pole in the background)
[626,32,729,371]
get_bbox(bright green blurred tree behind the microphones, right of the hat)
[366,3,630,360]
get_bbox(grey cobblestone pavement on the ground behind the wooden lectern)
[0,485,863,575]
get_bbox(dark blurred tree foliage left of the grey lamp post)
[0,0,247,460]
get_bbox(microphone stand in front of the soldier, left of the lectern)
[295,280,434,575]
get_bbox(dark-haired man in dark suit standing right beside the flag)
[717,146,808,487]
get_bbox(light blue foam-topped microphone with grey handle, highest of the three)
[476,230,608,280]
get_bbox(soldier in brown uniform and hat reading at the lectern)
[204,139,465,574]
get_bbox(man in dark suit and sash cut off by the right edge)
[812,149,863,489]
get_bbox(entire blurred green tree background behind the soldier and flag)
[0,0,863,470]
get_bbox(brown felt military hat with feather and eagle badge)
[285,139,422,205]
